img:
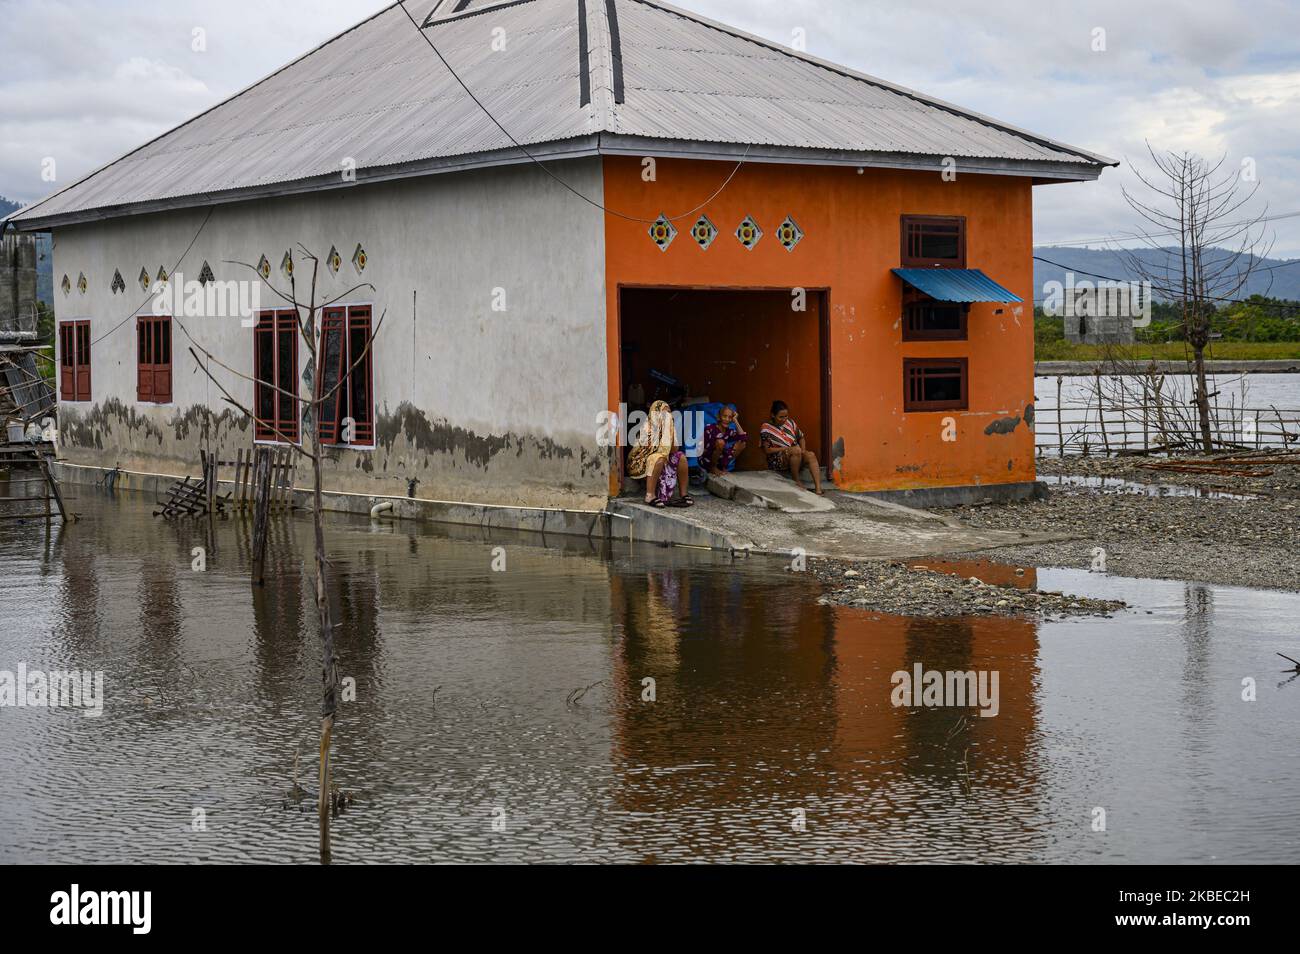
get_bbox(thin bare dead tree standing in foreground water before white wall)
[183,246,387,862]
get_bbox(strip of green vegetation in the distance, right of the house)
[1034,295,1300,361]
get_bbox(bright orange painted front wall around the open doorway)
[605,156,1034,490]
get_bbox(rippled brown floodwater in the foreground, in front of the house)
[0,489,1300,863]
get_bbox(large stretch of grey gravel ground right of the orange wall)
[936,458,1300,590]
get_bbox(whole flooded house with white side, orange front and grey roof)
[9,0,1113,522]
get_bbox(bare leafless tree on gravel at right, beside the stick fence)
[1117,143,1273,454]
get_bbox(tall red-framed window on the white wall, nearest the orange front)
[317,305,374,446]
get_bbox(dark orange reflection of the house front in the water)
[612,571,1037,812]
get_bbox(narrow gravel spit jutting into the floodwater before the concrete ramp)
[809,560,1126,617]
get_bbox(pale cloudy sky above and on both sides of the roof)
[0,0,1300,257]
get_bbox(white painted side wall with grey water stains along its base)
[55,159,608,508]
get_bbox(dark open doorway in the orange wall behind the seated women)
[621,289,822,469]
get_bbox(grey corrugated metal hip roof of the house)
[12,0,1109,225]
